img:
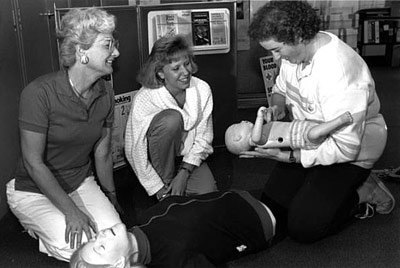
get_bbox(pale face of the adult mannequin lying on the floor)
[81,223,131,264]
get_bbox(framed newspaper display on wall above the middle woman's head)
[147,8,230,54]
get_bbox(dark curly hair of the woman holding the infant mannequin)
[248,0,320,45]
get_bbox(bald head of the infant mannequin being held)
[225,121,253,154]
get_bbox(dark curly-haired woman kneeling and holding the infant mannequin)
[241,1,395,242]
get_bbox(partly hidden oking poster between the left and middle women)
[111,90,137,168]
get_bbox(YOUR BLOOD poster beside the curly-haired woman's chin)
[260,56,279,105]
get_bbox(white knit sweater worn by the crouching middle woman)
[125,77,214,195]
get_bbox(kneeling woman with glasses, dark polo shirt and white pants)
[7,8,121,261]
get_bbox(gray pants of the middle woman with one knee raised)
[146,109,217,195]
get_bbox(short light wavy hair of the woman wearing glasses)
[57,7,116,68]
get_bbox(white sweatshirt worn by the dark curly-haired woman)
[273,32,387,168]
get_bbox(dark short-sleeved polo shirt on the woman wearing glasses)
[15,71,114,193]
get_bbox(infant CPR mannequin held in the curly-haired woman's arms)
[225,107,353,154]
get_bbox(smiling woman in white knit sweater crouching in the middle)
[125,35,217,200]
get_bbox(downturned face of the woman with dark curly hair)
[260,39,307,64]
